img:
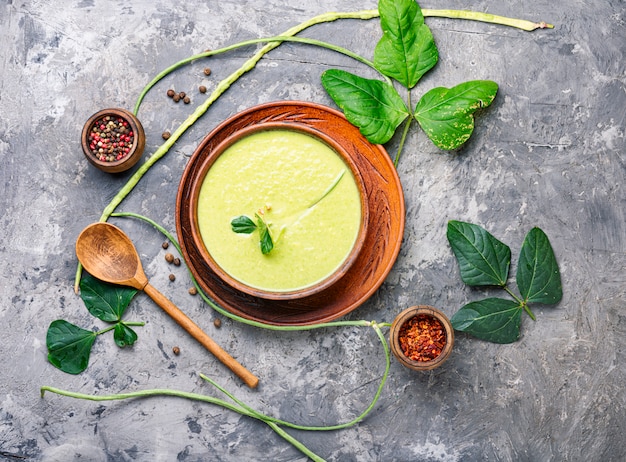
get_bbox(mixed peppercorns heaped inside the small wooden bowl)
[89,115,135,162]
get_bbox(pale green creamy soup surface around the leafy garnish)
[197,130,361,292]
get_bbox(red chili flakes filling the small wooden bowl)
[398,314,446,362]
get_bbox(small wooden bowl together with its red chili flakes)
[389,305,454,371]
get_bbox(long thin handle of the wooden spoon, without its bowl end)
[143,283,259,388]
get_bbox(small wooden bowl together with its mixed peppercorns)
[81,108,146,173]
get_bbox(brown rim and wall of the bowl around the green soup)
[189,122,369,300]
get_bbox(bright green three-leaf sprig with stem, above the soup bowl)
[322,0,498,165]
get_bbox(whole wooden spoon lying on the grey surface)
[76,222,259,388]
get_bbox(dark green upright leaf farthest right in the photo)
[516,228,563,305]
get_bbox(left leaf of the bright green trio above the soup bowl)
[322,69,409,144]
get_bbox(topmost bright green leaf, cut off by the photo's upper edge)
[374,0,439,89]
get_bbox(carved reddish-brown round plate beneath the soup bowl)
[176,101,405,325]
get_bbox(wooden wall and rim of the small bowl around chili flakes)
[389,305,454,371]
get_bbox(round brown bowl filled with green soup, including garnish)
[190,122,369,300]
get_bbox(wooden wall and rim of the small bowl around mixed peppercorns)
[81,108,146,173]
